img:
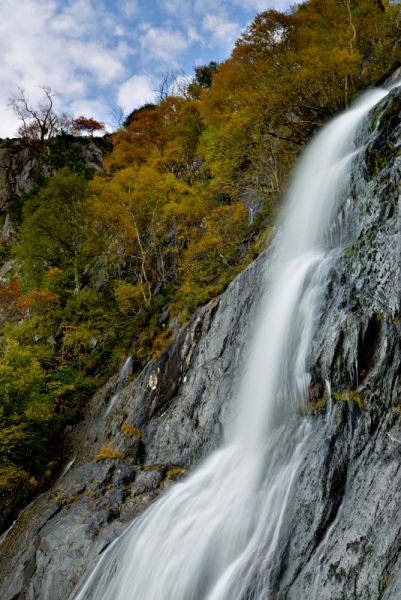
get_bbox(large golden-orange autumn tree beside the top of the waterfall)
[200,0,401,198]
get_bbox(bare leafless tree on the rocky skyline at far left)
[8,86,69,142]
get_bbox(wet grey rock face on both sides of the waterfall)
[0,85,401,600]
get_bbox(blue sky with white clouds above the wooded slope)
[0,0,289,138]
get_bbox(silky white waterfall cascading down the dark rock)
[72,90,387,600]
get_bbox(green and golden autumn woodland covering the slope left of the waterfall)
[0,0,401,524]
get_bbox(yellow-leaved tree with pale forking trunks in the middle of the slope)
[90,166,199,307]
